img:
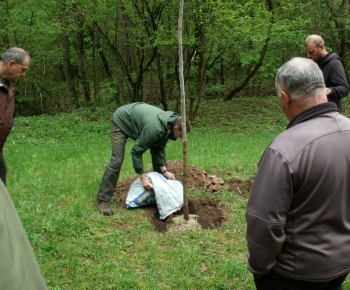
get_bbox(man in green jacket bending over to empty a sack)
[97,103,191,215]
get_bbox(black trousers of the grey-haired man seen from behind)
[254,271,348,290]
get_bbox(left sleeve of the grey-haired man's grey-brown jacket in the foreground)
[246,149,293,277]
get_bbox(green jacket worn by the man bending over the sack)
[113,103,178,174]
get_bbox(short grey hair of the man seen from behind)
[275,57,325,101]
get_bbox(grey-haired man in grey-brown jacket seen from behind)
[246,58,350,290]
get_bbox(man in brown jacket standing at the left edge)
[0,47,30,185]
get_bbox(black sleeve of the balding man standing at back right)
[325,59,349,99]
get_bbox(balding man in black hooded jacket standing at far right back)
[304,34,349,111]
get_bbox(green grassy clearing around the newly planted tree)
[4,97,350,290]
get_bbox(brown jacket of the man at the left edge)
[0,78,15,157]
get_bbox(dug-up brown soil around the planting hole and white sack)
[115,160,252,232]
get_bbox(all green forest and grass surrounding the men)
[0,0,350,290]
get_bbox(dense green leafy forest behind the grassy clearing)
[0,0,350,121]
